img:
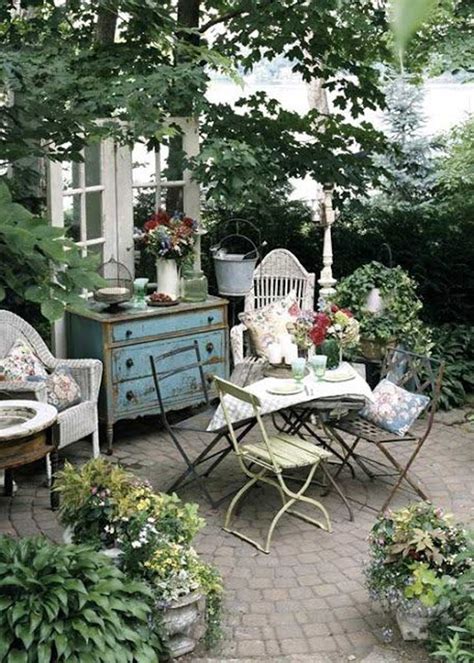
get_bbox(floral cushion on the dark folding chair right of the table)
[361,379,430,436]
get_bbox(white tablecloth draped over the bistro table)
[207,363,372,431]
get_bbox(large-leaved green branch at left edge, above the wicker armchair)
[0,181,102,321]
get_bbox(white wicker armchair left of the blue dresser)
[0,310,102,482]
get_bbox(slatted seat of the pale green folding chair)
[241,433,332,469]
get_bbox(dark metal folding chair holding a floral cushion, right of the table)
[330,348,444,512]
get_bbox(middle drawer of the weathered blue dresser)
[112,329,226,382]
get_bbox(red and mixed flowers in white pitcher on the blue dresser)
[142,209,198,299]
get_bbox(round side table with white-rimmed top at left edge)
[0,400,59,510]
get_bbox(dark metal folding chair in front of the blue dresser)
[150,341,254,508]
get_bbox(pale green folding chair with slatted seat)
[214,377,331,553]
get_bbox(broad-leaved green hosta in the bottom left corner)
[0,537,159,663]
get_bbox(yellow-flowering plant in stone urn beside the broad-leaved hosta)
[56,459,222,657]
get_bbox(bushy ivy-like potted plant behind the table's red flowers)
[335,261,430,359]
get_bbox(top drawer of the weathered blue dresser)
[112,307,224,343]
